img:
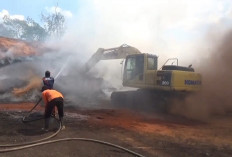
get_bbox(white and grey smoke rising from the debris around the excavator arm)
[0,0,232,108]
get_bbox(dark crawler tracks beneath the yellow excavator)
[111,89,188,112]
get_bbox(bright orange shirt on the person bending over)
[42,89,64,104]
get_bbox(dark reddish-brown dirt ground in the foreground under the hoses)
[0,103,232,157]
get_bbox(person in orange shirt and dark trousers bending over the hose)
[41,86,65,131]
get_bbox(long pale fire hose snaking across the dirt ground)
[0,98,144,157]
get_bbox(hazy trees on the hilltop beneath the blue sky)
[0,12,65,41]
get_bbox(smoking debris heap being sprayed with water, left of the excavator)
[0,37,115,104]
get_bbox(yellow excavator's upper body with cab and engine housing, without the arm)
[123,53,201,91]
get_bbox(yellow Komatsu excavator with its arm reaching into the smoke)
[85,44,202,109]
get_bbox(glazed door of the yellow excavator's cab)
[123,54,144,86]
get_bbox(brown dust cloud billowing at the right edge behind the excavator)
[170,30,232,120]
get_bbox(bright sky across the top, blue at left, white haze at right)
[0,0,232,64]
